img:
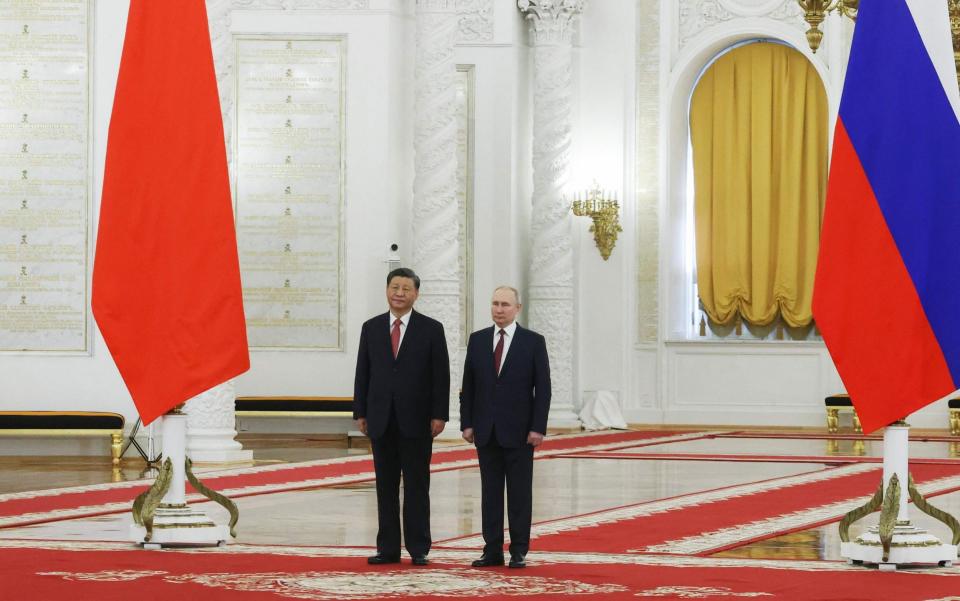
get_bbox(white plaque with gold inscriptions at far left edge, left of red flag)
[0,0,91,353]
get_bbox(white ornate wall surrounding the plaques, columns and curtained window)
[0,0,946,442]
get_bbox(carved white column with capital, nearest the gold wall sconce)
[517,0,584,428]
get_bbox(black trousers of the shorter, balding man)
[477,433,533,555]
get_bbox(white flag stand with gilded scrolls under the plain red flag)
[130,406,240,549]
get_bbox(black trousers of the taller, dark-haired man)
[370,412,433,556]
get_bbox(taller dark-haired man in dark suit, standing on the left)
[353,268,450,565]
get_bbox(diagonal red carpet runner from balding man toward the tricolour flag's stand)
[442,464,960,554]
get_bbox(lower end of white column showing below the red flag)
[183,380,253,463]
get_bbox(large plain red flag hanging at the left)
[92,0,250,424]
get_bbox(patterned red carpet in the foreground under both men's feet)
[0,541,960,601]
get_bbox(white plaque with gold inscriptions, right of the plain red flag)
[234,36,345,350]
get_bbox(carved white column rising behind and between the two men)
[412,0,462,439]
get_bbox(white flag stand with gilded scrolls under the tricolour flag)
[840,420,960,571]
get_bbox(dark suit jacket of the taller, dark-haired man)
[353,311,450,438]
